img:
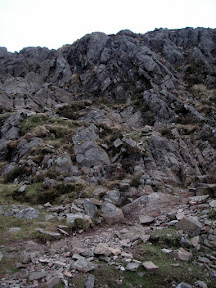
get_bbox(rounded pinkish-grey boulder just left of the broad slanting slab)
[101,201,124,225]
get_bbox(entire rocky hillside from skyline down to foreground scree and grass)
[0,28,216,288]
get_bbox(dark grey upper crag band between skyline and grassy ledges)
[0,28,216,110]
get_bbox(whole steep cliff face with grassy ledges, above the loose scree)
[0,28,216,189]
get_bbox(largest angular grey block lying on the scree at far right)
[176,217,202,236]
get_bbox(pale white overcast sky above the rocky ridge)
[0,0,216,52]
